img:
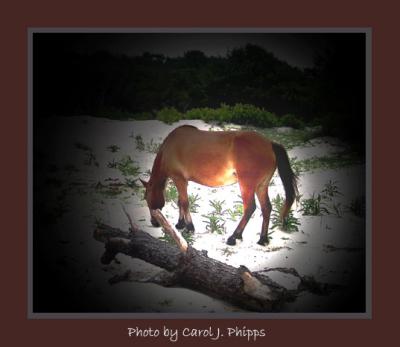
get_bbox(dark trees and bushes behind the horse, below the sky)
[33,34,365,150]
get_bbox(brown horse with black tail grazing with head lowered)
[141,125,297,245]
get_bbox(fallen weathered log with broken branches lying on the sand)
[94,210,338,312]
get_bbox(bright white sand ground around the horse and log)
[39,117,365,312]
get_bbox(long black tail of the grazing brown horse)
[272,142,299,220]
